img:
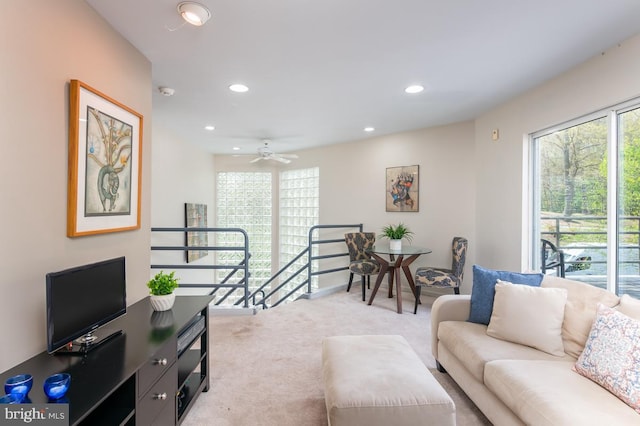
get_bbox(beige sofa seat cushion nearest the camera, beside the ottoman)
[484,360,640,426]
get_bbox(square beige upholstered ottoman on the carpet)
[322,336,456,426]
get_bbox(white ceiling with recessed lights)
[86,0,640,154]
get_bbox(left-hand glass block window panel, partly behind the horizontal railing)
[216,172,273,303]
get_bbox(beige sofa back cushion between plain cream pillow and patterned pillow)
[541,275,620,358]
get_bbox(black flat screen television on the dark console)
[46,257,127,354]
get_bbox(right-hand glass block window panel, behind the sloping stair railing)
[279,167,320,294]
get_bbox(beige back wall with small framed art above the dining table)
[216,122,476,292]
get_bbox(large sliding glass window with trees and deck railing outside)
[531,101,640,296]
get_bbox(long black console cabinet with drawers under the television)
[0,296,213,426]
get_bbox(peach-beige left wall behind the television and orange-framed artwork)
[0,0,152,371]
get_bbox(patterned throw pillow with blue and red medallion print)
[574,303,640,413]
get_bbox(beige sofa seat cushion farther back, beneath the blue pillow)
[438,321,575,382]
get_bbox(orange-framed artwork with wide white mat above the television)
[67,80,142,237]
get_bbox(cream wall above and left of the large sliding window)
[475,36,640,270]
